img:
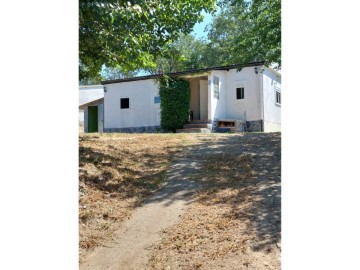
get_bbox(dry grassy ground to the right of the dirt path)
[148,134,281,270]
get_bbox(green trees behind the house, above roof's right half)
[151,0,281,73]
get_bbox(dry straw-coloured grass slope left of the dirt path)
[79,134,200,260]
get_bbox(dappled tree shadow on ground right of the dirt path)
[191,133,281,252]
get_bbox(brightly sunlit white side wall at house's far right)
[262,68,281,132]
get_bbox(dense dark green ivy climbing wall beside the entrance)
[159,76,190,132]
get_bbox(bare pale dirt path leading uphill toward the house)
[80,155,199,270]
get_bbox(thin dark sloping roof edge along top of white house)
[101,61,264,85]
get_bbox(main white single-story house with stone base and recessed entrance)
[102,62,281,132]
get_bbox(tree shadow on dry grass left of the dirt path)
[79,146,180,199]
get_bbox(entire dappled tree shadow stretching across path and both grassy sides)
[79,133,281,251]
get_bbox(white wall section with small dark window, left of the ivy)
[104,80,160,129]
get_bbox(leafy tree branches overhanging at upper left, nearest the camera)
[79,0,215,79]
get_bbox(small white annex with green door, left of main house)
[79,85,104,132]
